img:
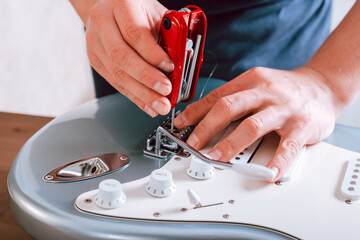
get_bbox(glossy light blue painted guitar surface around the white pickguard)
[8,79,360,240]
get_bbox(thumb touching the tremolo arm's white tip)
[267,128,306,182]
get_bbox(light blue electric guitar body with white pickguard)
[8,79,360,239]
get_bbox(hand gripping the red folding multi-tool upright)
[86,0,174,117]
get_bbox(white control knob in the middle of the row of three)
[145,169,176,197]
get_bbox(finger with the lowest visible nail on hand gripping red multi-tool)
[87,27,171,115]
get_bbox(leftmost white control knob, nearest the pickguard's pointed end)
[94,179,126,209]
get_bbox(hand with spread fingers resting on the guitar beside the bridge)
[175,67,337,181]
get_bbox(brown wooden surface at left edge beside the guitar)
[0,112,52,239]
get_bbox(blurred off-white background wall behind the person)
[0,0,360,127]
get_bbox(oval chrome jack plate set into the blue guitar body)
[43,153,130,182]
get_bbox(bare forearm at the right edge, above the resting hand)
[306,1,360,115]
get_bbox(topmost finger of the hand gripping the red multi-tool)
[114,1,174,72]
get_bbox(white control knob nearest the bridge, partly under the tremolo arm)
[186,154,215,180]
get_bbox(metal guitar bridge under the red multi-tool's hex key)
[144,110,195,160]
